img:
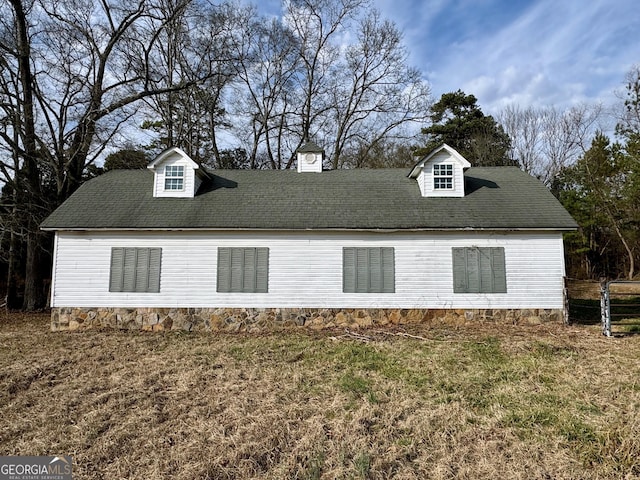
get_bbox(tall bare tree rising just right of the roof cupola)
[327,10,430,168]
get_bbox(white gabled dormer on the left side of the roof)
[147,147,207,198]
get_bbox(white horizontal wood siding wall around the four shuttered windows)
[52,232,564,308]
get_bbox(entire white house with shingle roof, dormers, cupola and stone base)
[42,143,577,329]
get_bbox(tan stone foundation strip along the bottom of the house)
[51,307,564,332]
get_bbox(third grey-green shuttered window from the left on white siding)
[342,247,396,293]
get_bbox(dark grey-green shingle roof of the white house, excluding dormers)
[42,167,577,230]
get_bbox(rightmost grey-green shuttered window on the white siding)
[452,247,507,293]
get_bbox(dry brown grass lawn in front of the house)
[0,314,640,479]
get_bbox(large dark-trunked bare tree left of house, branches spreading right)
[0,0,230,309]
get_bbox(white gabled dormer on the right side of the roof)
[409,143,471,197]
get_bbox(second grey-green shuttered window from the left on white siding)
[217,247,269,293]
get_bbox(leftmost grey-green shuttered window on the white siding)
[109,247,162,293]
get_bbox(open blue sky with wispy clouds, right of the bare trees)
[374,0,640,113]
